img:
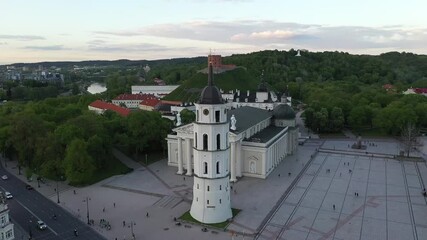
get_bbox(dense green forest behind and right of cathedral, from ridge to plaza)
[165,50,427,135]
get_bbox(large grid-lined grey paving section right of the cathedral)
[256,140,427,240]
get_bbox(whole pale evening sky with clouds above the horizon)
[0,0,427,64]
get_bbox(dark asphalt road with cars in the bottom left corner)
[0,167,106,240]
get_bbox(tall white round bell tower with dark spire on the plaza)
[190,63,232,223]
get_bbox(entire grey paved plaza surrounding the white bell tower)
[8,139,427,240]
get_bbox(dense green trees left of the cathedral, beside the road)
[0,95,172,185]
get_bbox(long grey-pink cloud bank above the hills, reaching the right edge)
[94,20,427,53]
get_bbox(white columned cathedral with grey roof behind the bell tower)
[166,65,298,182]
